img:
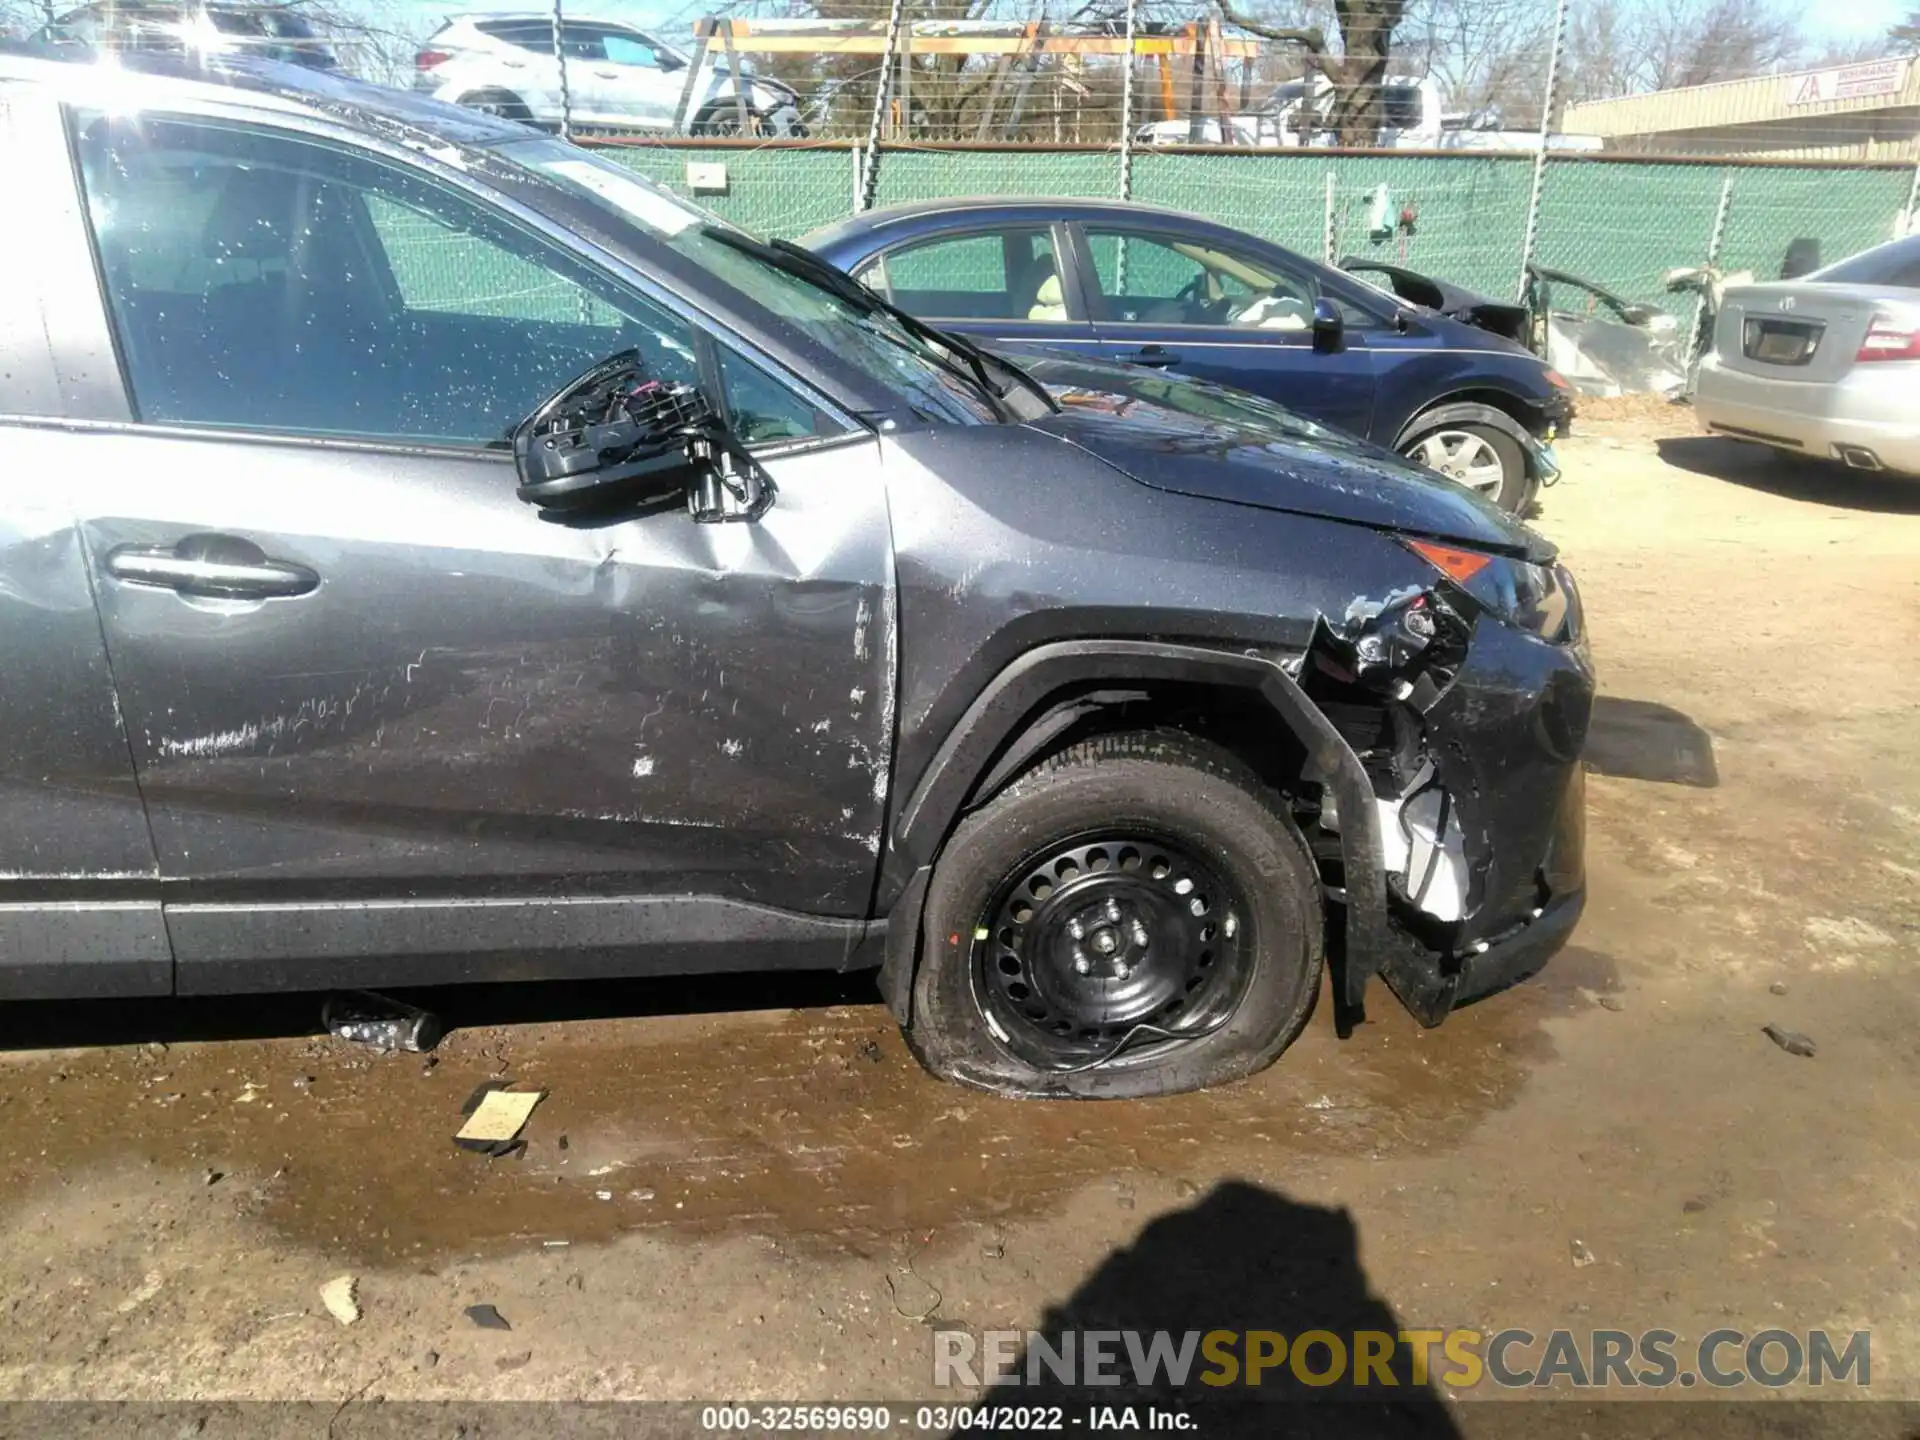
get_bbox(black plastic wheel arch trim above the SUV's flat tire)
[879,639,1394,1029]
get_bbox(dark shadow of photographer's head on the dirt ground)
[954,1181,1461,1440]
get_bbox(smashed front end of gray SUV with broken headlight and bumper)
[1296,541,1594,1025]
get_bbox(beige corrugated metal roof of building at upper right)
[1561,56,1920,136]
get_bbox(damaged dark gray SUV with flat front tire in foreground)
[0,50,1592,1096]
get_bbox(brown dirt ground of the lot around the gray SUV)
[0,407,1920,1434]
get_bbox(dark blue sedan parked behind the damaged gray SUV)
[801,198,1572,513]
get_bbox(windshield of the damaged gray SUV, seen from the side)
[497,140,1002,424]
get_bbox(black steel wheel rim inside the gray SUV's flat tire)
[973,833,1248,1068]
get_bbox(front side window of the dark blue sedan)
[1087,228,1319,330]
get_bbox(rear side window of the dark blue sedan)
[860,227,1069,321]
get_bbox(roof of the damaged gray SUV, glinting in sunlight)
[0,48,530,150]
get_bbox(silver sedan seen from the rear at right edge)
[1693,234,1920,474]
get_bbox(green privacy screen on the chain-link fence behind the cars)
[587,144,1914,303]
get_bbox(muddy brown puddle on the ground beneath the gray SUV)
[0,948,1615,1267]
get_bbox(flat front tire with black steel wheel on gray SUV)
[906,732,1325,1098]
